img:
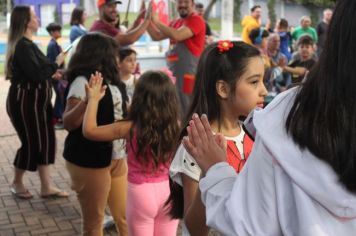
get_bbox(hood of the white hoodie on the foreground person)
[245,88,356,220]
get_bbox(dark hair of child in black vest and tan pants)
[66,33,128,117]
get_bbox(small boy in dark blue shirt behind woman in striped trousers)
[46,23,67,129]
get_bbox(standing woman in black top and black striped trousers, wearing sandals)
[5,5,68,199]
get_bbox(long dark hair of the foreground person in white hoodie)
[286,0,356,193]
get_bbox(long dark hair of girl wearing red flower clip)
[167,41,260,218]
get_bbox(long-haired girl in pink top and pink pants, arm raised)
[83,71,179,236]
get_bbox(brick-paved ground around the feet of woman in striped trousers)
[0,76,117,236]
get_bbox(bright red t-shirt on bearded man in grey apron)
[169,13,205,57]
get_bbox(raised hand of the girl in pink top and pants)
[85,71,106,101]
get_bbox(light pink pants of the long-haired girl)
[126,180,178,236]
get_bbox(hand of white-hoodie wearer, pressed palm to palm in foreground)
[183,114,226,174]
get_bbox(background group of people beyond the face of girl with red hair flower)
[241,5,332,101]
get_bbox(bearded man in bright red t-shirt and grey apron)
[147,0,205,114]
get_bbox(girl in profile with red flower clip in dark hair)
[168,41,267,235]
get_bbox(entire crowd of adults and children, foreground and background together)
[5,0,356,236]
